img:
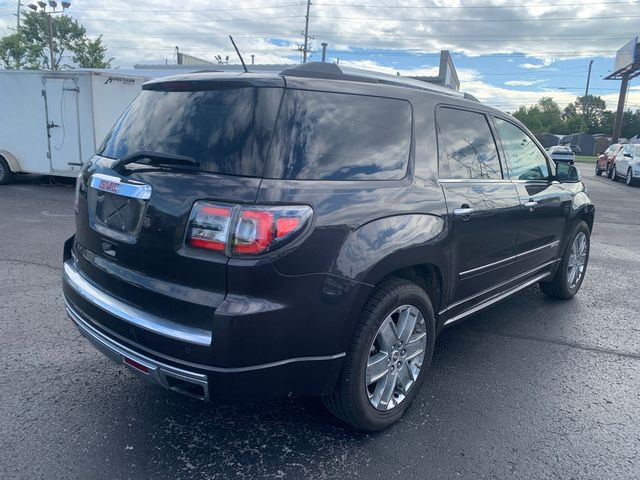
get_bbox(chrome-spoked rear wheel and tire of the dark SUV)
[322,278,435,431]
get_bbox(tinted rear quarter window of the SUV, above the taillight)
[265,90,412,180]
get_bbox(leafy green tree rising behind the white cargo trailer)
[0,11,113,69]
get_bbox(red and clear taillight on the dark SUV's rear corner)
[185,202,313,255]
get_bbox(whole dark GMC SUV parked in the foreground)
[64,63,594,430]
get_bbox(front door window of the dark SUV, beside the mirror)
[494,118,549,180]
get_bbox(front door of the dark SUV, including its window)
[493,118,572,274]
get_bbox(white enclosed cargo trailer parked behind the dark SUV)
[0,70,157,183]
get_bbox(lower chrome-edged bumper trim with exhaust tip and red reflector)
[64,298,210,401]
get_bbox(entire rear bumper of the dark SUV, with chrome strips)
[63,237,356,401]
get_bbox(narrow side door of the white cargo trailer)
[43,77,82,174]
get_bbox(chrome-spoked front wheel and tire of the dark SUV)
[540,220,591,300]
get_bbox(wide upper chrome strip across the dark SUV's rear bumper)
[64,260,211,347]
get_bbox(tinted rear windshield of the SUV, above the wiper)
[98,87,283,176]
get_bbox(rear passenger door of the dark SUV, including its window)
[436,107,520,315]
